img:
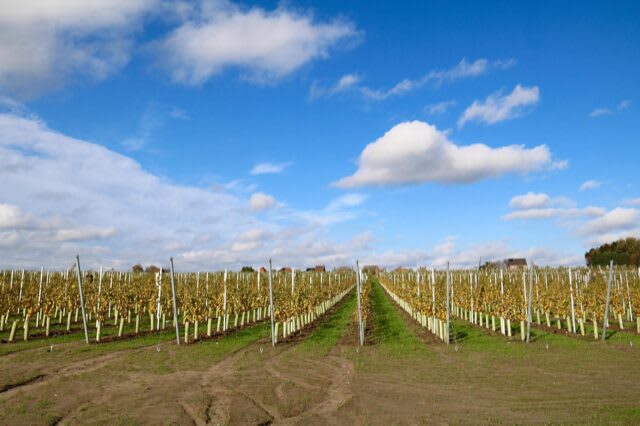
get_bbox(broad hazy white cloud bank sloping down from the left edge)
[0,113,378,270]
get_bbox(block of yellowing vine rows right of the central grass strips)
[381,267,640,343]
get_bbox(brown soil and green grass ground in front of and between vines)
[0,268,640,424]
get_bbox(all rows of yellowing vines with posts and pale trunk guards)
[0,260,640,345]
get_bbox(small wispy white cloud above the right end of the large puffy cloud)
[458,84,540,127]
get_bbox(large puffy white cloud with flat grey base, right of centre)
[335,121,553,188]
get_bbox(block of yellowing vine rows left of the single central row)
[0,260,356,344]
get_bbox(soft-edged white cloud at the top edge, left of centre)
[155,1,358,85]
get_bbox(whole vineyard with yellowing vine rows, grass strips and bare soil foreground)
[0,260,640,424]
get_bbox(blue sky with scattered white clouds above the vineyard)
[0,0,640,270]
